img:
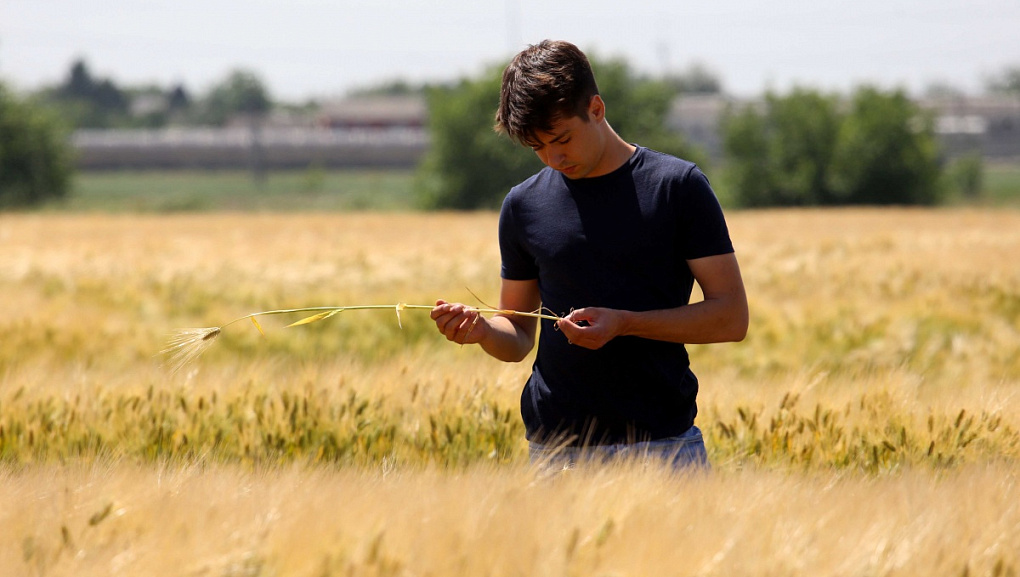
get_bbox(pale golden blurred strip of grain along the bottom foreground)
[0,463,1020,577]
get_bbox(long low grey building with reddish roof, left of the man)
[72,97,428,170]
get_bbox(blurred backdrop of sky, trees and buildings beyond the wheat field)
[0,0,1020,210]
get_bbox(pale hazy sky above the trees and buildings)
[0,0,1020,102]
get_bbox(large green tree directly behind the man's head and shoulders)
[416,57,701,210]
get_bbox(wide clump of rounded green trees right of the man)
[723,88,940,206]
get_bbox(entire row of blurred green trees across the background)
[0,55,1020,210]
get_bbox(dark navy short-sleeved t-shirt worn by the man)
[499,148,733,444]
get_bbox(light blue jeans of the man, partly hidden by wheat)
[528,426,711,472]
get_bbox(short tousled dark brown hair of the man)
[496,40,599,147]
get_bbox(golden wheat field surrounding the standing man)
[0,209,1020,576]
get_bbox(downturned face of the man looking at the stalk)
[532,96,608,179]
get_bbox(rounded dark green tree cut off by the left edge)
[0,84,71,208]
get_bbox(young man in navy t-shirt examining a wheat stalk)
[431,41,748,467]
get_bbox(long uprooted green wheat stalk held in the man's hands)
[159,303,562,373]
